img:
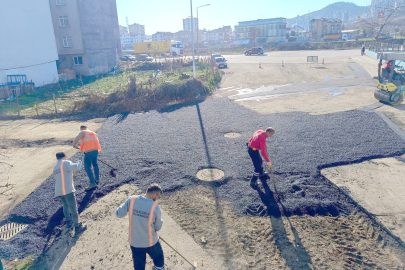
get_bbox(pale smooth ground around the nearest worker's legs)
[29,184,218,270]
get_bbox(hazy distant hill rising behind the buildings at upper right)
[287,2,370,29]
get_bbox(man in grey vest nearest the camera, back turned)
[115,184,165,270]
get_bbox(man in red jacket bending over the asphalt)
[248,127,276,188]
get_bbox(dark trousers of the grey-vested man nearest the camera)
[131,242,165,270]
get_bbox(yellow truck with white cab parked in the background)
[134,40,184,56]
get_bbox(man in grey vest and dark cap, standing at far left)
[53,152,86,237]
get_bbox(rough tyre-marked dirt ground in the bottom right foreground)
[161,186,405,269]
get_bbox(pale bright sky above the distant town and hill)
[116,0,371,35]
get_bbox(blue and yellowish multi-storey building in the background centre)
[235,18,287,42]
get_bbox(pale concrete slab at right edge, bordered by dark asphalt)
[321,155,405,241]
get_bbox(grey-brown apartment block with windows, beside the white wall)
[49,0,122,76]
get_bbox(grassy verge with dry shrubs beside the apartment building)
[0,57,221,116]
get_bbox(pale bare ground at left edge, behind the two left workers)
[0,118,104,219]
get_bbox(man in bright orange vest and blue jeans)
[73,126,101,191]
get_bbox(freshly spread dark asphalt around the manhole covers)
[0,99,405,258]
